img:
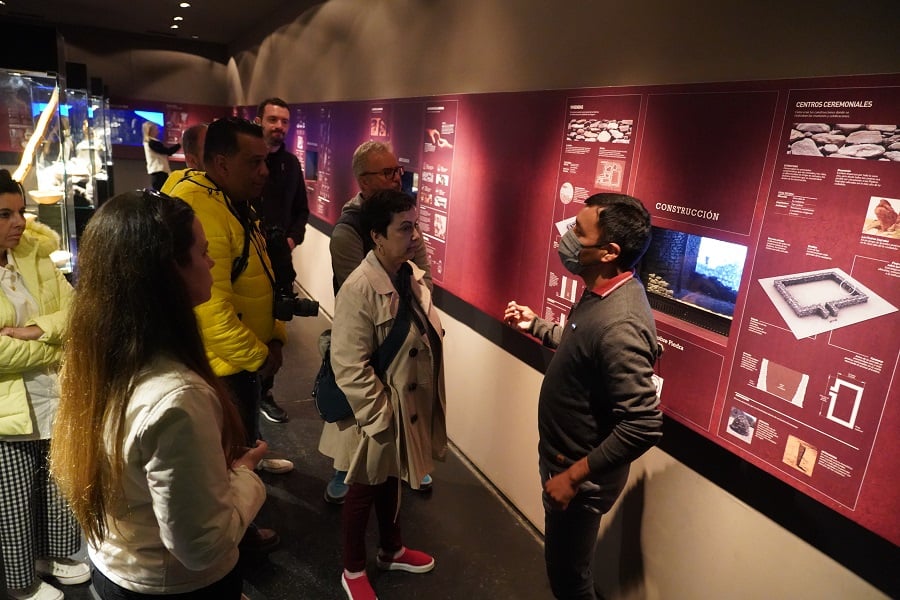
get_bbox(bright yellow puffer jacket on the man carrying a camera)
[169,171,286,377]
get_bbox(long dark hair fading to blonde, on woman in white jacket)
[50,191,244,545]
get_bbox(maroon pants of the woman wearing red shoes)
[341,477,403,573]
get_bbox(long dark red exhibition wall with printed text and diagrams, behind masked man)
[284,75,900,544]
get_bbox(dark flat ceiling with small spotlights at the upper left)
[0,0,306,46]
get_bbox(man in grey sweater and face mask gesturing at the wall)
[504,194,662,600]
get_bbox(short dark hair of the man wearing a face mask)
[584,194,651,269]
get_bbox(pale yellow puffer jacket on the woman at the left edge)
[0,221,72,436]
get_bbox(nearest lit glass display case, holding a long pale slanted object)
[0,68,77,272]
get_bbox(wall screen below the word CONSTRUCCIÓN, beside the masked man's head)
[640,227,747,335]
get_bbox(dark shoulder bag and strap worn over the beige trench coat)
[312,276,411,423]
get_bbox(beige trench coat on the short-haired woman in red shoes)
[319,252,447,488]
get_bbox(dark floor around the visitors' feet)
[59,317,551,600]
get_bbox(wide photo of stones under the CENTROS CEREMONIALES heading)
[788,123,900,162]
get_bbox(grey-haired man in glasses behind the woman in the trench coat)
[319,142,432,504]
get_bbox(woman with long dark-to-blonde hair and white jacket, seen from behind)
[51,191,266,600]
